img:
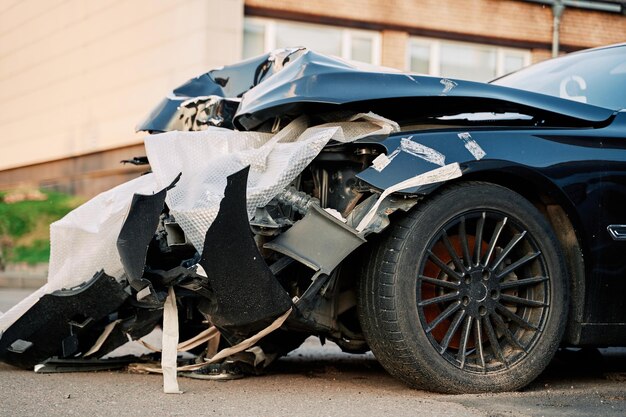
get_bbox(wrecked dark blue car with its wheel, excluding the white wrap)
[0,45,626,393]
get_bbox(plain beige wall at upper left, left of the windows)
[0,0,244,171]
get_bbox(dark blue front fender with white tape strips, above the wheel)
[359,112,626,334]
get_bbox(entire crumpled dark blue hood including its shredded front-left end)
[137,48,614,132]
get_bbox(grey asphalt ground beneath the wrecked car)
[0,289,626,417]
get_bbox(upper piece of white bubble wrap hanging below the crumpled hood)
[145,114,397,251]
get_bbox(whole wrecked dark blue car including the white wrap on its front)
[0,45,626,393]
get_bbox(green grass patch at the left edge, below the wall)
[0,191,82,264]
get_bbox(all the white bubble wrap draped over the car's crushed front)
[0,113,399,332]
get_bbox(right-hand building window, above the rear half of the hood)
[407,38,530,81]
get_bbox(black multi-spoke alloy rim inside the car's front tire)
[417,209,550,372]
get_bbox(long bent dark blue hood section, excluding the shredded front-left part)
[234,51,611,130]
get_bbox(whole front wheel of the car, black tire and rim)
[359,182,568,393]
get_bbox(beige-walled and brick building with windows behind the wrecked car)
[0,0,626,196]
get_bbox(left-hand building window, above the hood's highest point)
[243,17,381,65]
